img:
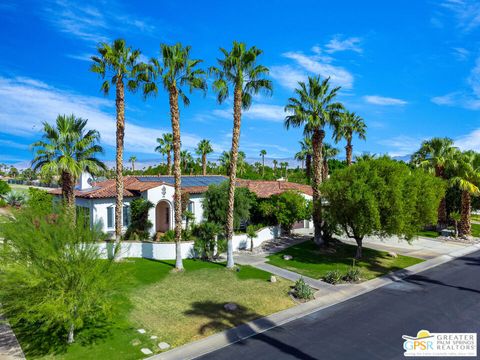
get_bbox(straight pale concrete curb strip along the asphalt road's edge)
[148,244,480,360]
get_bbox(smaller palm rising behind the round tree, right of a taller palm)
[333,111,367,166]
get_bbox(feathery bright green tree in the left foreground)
[0,204,117,348]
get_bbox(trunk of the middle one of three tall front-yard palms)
[169,84,183,270]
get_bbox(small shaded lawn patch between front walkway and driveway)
[268,241,423,280]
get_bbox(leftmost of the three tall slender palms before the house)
[90,39,145,244]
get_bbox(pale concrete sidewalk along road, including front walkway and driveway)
[149,238,480,360]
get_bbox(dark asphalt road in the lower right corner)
[200,252,480,360]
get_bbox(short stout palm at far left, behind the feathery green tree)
[32,115,106,219]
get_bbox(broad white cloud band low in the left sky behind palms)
[0,77,200,153]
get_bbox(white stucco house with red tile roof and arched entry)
[51,173,312,236]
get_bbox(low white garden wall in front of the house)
[99,226,280,260]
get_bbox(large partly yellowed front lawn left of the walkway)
[19,259,294,359]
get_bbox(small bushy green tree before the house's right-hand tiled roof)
[259,190,312,233]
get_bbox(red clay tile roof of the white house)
[50,176,313,199]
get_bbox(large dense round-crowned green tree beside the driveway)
[321,157,445,258]
